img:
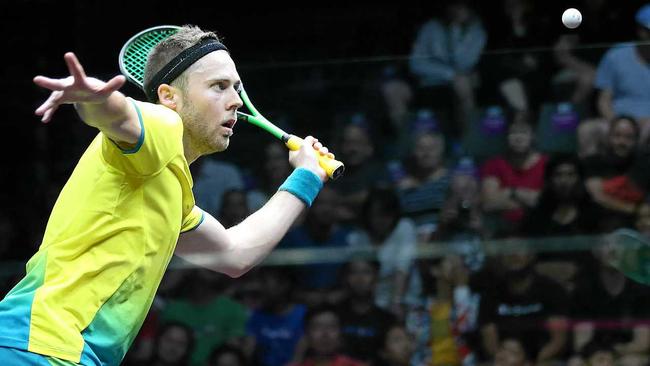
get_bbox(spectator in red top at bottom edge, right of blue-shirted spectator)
[292,305,365,366]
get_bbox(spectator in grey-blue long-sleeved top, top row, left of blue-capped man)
[410,0,487,136]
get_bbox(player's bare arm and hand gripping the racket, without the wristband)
[176,137,333,277]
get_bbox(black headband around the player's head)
[144,38,228,103]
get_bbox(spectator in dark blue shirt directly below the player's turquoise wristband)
[279,186,350,306]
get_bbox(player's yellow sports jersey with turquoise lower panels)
[0,100,203,366]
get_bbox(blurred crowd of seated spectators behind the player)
[0,0,650,366]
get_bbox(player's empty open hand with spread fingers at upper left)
[34,52,126,123]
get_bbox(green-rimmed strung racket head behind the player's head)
[118,25,181,89]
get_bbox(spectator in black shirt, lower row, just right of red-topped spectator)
[338,257,396,362]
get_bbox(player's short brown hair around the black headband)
[144,24,221,89]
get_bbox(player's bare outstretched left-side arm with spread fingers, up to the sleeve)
[34,52,141,146]
